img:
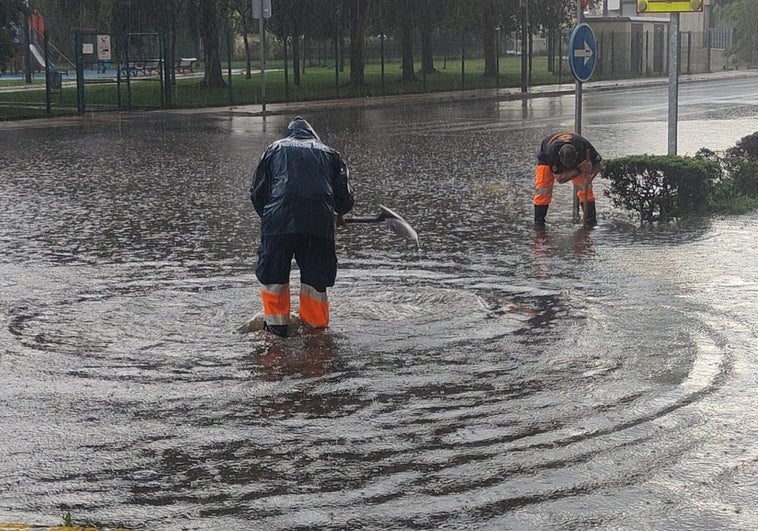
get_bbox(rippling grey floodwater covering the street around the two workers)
[0,77,758,530]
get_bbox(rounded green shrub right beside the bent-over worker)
[602,154,721,221]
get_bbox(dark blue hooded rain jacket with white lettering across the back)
[250,117,354,239]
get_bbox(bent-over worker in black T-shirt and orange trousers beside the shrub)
[534,133,603,228]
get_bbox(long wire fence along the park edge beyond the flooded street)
[0,21,732,118]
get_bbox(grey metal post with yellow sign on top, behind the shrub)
[637,0,703,155]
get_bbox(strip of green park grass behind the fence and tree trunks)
[0,57,572,119]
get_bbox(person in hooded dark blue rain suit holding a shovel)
[250,116,354,336]
